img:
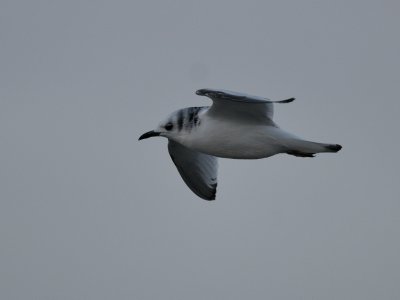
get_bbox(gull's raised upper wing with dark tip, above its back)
[196,89,295,124]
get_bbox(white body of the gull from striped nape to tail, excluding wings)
[166,106,333,159]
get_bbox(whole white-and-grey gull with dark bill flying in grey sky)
[139,89,342,200]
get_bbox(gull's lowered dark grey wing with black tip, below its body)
[168,140,218,200]
